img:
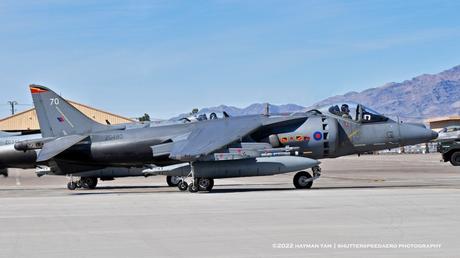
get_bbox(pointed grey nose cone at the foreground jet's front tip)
[401,124,438,145]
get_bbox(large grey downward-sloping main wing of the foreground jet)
[170,116,263,161]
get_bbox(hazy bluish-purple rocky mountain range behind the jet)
[180,65,460,122]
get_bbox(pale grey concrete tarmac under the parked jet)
[0,154,460,257]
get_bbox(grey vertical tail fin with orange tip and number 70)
[30,84,111,137]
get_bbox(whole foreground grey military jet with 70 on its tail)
[16,85,437,192]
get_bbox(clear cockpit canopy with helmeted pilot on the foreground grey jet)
[323,103,389,123]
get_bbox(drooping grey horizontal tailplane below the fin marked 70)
[37,135,88,162]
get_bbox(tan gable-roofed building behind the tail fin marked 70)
[0,101,134,133]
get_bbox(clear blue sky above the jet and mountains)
[0,0,460,118]
